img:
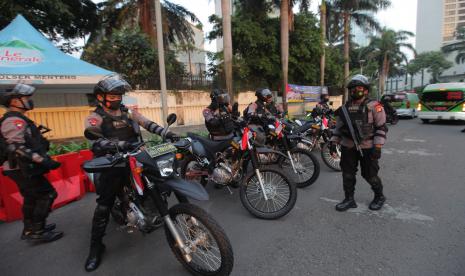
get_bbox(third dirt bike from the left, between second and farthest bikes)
[259,117,320,188]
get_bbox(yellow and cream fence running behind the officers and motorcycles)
[0,91,342,140]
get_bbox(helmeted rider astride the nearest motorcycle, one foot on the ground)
[85,75,177,271]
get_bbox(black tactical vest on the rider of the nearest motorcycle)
[94,107,141,143]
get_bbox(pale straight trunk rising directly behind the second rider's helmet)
[221,0,234,101]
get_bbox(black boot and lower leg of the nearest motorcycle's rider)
[85,205,110,272]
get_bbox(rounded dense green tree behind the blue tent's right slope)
[82,28,185,88]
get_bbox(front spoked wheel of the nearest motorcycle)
[165,203,234,275]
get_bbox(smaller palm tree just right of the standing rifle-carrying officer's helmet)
[367,28,416,95]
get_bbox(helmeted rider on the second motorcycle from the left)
[203,89,238,141]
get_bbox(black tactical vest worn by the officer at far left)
[0,111,50,176]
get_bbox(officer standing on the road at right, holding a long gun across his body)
[330,75,387,211]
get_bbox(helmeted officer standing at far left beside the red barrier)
[0,83,63,242]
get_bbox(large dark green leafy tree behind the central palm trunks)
[208,11,340,90]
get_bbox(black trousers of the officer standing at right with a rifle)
[341,147,383,197]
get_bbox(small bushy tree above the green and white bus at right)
[410,51,452,83]
